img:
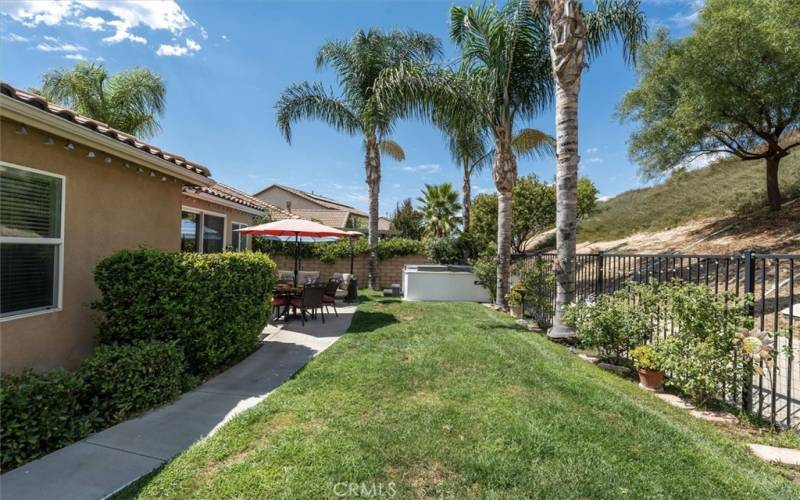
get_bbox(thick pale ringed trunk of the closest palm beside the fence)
[547,0,586,338]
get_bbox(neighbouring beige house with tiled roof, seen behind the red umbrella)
[253,184,391,234]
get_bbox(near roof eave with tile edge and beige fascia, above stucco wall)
[0,82,213,185]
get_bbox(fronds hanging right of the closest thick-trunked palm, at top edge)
[583,0,647,62]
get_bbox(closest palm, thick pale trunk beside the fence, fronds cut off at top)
[530,0,647,338]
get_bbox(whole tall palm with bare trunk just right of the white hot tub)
[376,1,553,305]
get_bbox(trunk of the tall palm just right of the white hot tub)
[492,134,517,308]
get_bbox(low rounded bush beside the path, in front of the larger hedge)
[78,341,186,427]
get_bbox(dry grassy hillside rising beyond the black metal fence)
[564,152,800,252]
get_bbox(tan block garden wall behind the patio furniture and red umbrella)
[270,254,431,288]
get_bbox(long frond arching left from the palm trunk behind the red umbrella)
[275,82,361,143]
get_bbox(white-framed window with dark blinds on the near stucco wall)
[0,162,65,318]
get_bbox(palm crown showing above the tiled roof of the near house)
[33,62,167,139]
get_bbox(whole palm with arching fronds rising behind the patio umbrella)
[275,29,441,288]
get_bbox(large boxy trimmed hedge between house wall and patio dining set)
[92,249,276,375]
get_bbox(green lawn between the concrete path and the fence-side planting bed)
[123,295,800,499]
